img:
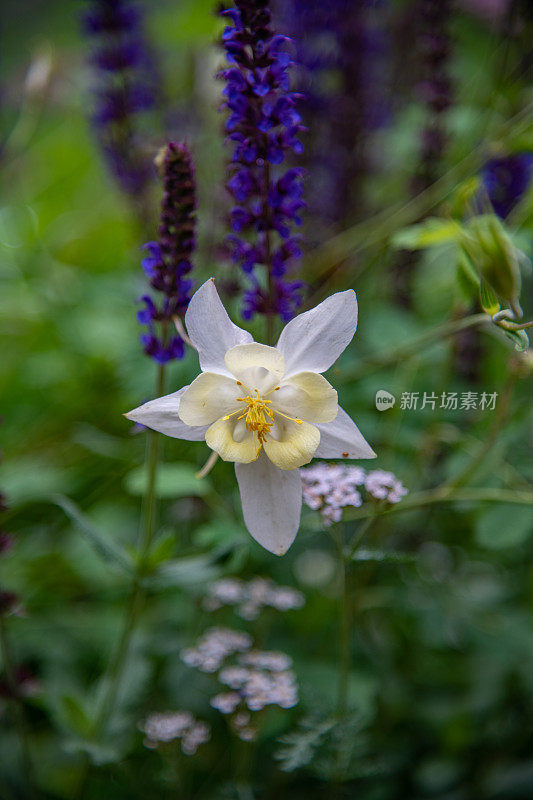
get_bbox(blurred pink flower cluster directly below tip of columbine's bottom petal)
[204,578,305,620]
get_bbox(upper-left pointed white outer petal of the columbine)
[185,278,253,375]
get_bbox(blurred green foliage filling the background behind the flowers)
[0,0,533,800]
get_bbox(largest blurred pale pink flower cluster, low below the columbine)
[181,628,298,741]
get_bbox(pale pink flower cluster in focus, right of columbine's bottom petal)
[300,462,408,526]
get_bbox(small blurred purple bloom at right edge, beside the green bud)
[481,152,533,219]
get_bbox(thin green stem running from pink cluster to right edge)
[344,486,533,521]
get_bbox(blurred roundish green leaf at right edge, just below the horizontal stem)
[475,503,533,550]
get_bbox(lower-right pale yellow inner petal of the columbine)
[264,412,320,469]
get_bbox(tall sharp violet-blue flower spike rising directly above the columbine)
[220,0,305,319]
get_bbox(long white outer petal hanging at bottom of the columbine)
[235,453,302,556]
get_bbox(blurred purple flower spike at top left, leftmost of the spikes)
[82,0,158,196]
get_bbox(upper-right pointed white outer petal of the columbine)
[276,289,357,377]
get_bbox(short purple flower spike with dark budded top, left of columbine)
[137,142,196,364]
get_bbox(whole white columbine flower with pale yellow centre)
[126,279,375,555]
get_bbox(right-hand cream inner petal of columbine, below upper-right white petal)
[270,372,339,422]
